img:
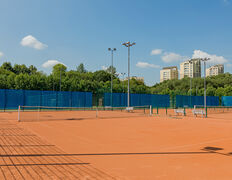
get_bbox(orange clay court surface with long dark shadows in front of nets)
[0,112,232,180]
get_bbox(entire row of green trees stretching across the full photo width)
[0,62,232,96]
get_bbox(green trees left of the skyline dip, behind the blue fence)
[0,62,150,93]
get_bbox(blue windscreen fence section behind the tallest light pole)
[104,93,170,107]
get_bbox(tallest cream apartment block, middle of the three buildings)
[180,59,201,79]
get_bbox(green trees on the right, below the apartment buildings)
[151,73,232,97]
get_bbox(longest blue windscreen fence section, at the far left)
[0,89,92,110]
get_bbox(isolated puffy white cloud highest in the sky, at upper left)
[21,35,48,50]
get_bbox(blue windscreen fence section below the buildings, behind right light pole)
[176,95,219,107]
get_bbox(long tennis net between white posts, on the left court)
[18,106,152,122]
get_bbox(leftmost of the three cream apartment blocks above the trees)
[160,66,178,82]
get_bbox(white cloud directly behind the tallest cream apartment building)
[192,50,228,64]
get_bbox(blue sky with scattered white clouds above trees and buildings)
[0,0,232,85]
